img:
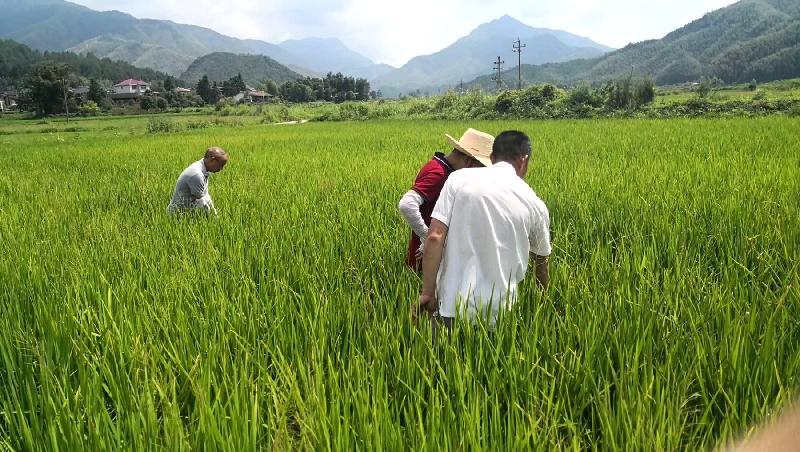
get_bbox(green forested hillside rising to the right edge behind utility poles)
[470,0,800,88]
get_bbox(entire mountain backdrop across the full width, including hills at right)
[0,0,800,92]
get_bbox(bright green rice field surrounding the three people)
[0,117,800,451]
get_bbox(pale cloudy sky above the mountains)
[70,0,734,66]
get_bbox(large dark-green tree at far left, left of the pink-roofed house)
[24,61,70,117]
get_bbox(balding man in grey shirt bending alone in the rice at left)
[167,147,228,215]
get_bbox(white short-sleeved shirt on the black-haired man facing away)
[431,162,552,324]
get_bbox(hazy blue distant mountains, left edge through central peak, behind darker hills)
[0,0,611,90]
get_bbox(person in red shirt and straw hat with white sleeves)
[397,129,494,272]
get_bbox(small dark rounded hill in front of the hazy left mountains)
[180,52,302,85]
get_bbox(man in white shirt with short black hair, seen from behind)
[411,131,552,328]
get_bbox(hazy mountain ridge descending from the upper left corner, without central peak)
[0,0,391,77]
